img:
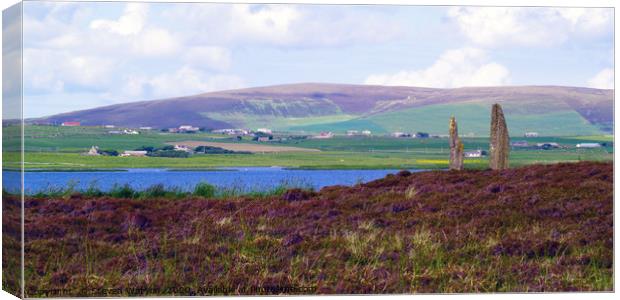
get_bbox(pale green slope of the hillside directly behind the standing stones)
[290,102,601,136]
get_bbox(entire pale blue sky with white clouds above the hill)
[14,1,614,117]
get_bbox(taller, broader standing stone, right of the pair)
[489,103,510,170]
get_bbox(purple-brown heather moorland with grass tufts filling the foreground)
[3,162,613,297]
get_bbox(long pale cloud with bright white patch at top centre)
[163,3,401,47]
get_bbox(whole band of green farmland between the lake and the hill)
[3,126,613,170]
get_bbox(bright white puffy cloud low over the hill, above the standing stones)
[364,48,510,88]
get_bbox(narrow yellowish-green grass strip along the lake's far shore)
[0,151,613,170]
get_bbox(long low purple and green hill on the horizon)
[36,83,613,136]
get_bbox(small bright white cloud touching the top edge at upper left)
[90,3,148,35]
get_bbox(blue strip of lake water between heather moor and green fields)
[3,167,420,194]
